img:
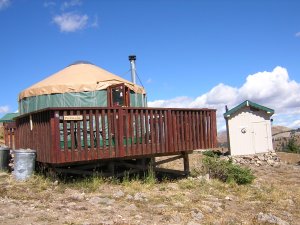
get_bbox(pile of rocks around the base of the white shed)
[222,151,280,167]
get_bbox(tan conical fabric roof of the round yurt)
[19,62,146,100]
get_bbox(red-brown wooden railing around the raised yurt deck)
[16,107,217,164]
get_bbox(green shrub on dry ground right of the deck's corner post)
[202,157,255,184]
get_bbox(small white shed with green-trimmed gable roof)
[224,100,274,155]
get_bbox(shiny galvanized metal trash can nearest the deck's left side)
[13,149,36,180]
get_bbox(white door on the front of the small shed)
[253,121,269,153]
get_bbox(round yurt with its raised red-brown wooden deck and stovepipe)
[15,56,216,176]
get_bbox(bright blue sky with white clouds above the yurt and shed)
[0,0,300,129]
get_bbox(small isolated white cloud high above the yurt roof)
[53,12,89,32]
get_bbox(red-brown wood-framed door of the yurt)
[108,84,129,107]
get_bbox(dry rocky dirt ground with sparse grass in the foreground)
[0,152,300,225]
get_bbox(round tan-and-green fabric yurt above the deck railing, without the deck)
[18,61,146,115]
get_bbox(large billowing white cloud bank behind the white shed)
[149,66,300,129]
